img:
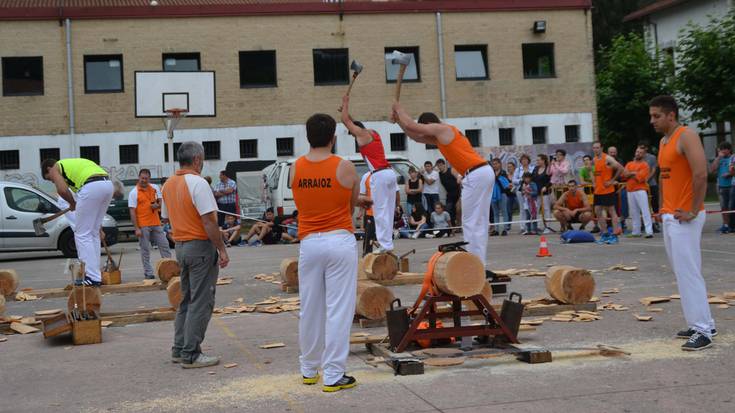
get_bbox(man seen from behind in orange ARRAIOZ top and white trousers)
[290,114,366,392]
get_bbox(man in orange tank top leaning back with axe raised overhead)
[391,103,495,270]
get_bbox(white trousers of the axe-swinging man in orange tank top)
[462,165,495,266]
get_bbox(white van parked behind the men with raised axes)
[263,155,421,216]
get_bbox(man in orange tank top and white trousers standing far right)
[648,96,717,351]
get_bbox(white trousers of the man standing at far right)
[662,211,715,338]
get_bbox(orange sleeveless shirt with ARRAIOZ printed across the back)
[291,155,354,239]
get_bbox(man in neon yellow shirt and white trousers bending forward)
[41,158,114,287]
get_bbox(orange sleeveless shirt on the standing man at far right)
[658,126,704,214]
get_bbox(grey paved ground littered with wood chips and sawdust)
[0,208,735,412]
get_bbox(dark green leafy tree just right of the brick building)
[597,33,670,158]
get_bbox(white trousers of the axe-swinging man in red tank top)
[370,169,398,251]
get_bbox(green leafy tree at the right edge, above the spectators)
[674,9,735,132]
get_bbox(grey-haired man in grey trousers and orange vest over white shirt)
[161,142,230,369]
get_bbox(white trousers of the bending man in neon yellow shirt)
[74,181,114,282]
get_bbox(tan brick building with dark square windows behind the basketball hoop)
[0,0,596,184]
